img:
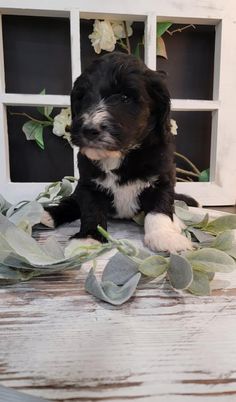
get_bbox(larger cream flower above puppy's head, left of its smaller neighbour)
[89,20,116,54]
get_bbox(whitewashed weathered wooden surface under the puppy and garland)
[0,210,236,402]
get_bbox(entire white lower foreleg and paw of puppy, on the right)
[144,213,192,253]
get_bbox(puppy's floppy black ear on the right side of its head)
[144,69,170,129]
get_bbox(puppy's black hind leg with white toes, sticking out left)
[41,196,81,228]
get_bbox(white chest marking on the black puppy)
[95,172,150,218]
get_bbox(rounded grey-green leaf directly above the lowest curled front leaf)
[102,253,138,285]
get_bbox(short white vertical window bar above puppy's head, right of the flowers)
[144,13,157,70]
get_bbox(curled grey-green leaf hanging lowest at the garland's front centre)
[85,269,141,306]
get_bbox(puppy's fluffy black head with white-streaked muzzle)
[70,53,170,159]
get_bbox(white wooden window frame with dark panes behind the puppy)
[0,0,236,205]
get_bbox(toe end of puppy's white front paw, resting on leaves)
[144,229,192,253]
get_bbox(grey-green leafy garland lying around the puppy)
[0,178,236,305]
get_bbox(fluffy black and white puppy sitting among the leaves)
[42,53,196,252]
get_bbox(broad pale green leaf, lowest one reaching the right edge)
[185,248,236,272]
